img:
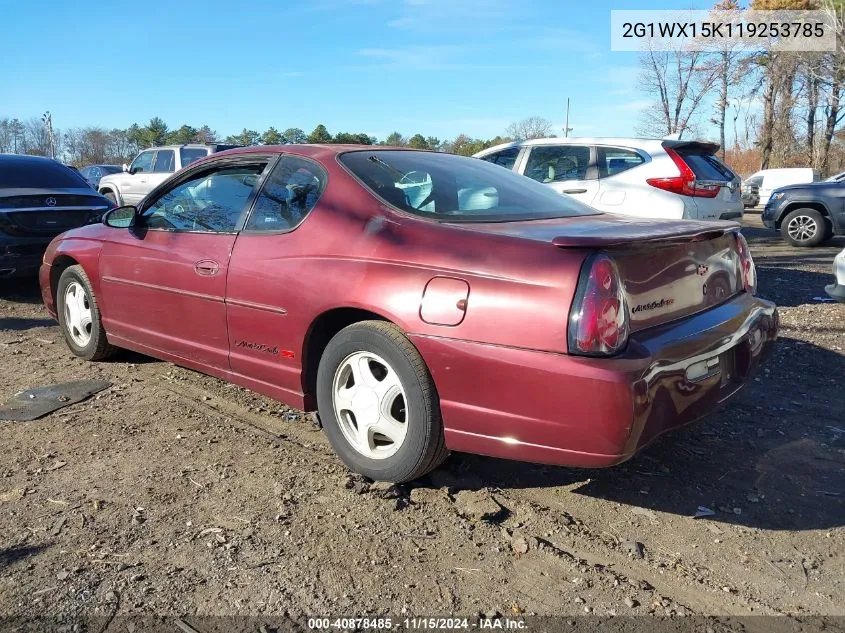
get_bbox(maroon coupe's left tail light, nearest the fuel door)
[569,255,629,356]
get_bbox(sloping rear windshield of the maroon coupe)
[340,150,598,222]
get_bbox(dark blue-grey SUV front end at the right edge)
[763,181,845,246]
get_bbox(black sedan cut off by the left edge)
[0,154,112,277]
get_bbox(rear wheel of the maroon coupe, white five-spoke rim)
[317,321,448,483]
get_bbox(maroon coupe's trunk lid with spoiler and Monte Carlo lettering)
[452,214,743,332]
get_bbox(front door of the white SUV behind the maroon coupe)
[522,144,599,204]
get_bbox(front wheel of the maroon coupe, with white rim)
[56,265,117,360]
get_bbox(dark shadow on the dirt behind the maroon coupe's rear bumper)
[433,339,845,530]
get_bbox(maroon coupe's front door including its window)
[100,156,268,369]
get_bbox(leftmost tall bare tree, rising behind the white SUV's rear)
[638,46,718,138]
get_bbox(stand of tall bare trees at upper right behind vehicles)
[637,0,845,175]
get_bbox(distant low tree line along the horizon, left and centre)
[0,117,553,166]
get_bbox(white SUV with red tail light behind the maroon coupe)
[475,137,743,220]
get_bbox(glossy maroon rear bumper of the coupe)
[411,294,778,467]
